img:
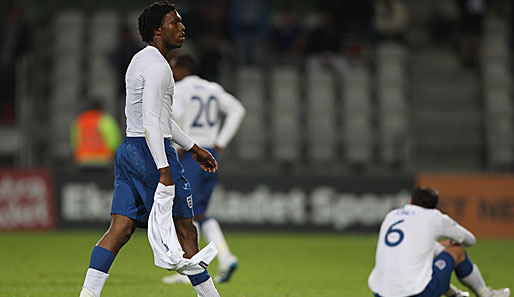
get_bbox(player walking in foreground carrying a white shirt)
[80,1,219,297]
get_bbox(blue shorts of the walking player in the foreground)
[111,137,193,228]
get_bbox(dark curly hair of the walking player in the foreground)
[137,1,177,43]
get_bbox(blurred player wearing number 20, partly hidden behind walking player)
[162,55,245,284]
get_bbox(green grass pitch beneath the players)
[0,230,514,297]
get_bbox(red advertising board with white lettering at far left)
[0,169,56,231]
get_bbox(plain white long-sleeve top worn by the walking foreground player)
[125,46,194,168]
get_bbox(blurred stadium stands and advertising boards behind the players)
[0,0,514,296]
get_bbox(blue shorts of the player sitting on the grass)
[374,252,455,297]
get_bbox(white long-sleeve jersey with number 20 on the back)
[173,75,245,148]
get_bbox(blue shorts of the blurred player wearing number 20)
[180,148,218,215]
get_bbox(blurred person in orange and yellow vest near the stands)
[70,102,121,167]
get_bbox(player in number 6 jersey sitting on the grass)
[368,187,510,297]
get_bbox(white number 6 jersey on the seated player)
[368,205,476,297]
